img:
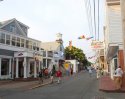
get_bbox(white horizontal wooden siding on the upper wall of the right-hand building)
[108,5,123,43]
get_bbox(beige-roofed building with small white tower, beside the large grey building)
[41,33,64,68]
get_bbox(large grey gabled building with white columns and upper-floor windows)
[0,18,42,79]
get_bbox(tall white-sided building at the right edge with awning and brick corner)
[104,0,124,79]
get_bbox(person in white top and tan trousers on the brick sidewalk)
[115,66,123,90]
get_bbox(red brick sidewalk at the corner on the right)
[99,76,125,92]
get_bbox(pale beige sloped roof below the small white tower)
[41,41,60,51]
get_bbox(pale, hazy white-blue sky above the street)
[0,0,104,62]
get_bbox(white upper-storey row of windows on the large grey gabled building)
[0,30,40,51]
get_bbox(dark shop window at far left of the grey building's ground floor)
[1,59,9,75]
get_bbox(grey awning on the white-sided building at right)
[106,46,119,61]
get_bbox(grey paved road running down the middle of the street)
[0,72,125,99]
